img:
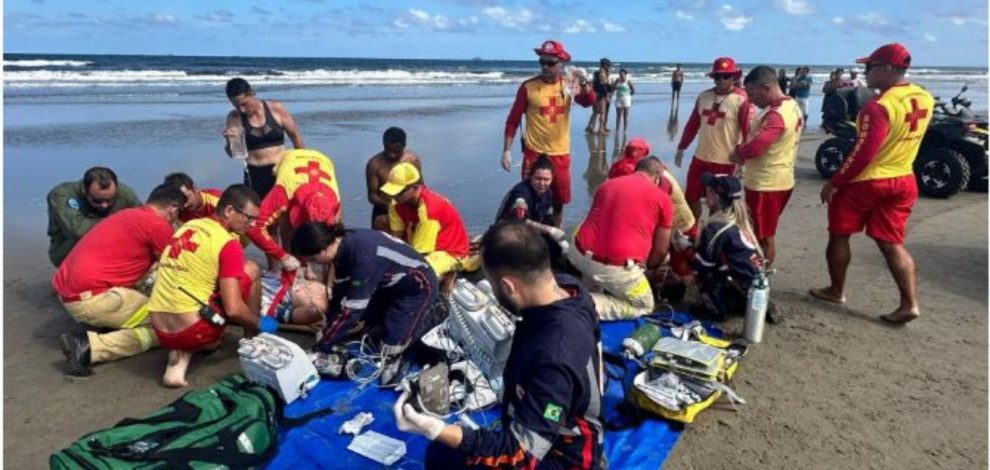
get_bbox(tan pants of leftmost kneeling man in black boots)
[62,287,158,364]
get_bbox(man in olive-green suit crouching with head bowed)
[47,166,141,267]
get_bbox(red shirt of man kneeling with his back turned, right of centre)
[575,172,674,266]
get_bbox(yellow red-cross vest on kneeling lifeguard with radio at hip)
[148,217,237,313]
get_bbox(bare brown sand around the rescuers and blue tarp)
[3,131,988,469]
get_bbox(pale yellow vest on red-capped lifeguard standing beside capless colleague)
[694,88,749,164]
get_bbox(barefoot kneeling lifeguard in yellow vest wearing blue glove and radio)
[147,184,270,387]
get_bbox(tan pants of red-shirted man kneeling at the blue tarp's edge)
[567,246,653,320]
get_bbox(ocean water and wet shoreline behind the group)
[3,54,987,268]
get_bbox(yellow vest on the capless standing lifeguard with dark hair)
[743,98,803,191]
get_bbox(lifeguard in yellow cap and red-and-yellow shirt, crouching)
[382,163,468,278]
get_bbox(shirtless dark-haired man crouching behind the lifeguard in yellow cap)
[364,127,423,232]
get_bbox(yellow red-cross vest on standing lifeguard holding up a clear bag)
[523,77,571,155]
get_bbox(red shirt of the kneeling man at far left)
[52,206,174,297]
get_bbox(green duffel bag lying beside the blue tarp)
[49,375,282,469]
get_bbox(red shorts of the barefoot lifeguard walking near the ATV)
[828,175,918,245]
